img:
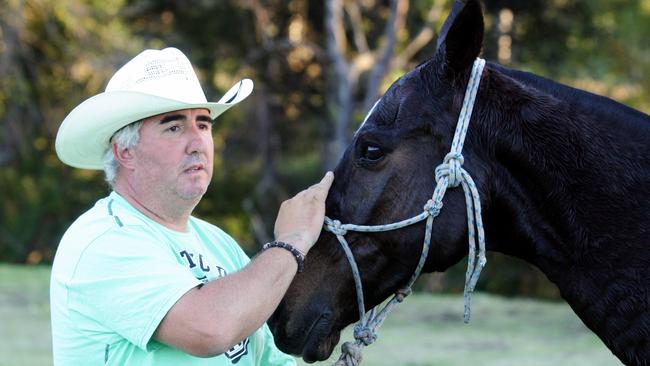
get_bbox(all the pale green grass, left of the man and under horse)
[0,265,621,366]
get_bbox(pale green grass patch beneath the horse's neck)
[302,293,622,366]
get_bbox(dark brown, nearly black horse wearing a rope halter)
[268,0,650,366]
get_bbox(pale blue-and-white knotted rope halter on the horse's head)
[325,58,487,366]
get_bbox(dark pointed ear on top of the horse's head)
[433,0,484,77]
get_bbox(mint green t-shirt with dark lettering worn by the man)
[50,192,296,366]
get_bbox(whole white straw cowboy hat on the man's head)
[55,48,253,169]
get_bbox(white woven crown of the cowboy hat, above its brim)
[106,47,207,104]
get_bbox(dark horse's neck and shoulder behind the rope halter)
[477,65,650,365]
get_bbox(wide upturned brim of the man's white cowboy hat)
[55,79,253,169]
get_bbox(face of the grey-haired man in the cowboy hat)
[134,109,214,202]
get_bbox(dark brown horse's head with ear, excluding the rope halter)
[269,0,483,362]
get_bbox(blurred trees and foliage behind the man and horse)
[0,0,650,299]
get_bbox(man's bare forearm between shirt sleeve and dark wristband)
[154,244,298,357]
